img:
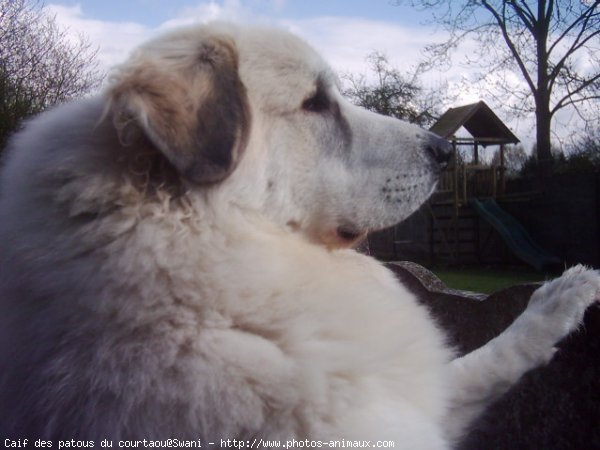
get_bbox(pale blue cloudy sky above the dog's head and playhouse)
[46,0,588,151]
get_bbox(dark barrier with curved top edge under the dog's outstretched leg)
[388,264,600,450]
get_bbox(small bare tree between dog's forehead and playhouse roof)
[342,52,441,126]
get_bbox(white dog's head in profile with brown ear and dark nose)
[107,24,450,247]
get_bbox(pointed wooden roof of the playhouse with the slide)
[430,101,519,145]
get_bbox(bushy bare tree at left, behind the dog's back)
[0,0,102,148]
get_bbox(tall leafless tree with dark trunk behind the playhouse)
[399,0,600,174]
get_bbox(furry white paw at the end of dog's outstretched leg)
[523,265,600,344]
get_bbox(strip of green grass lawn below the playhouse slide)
[431,267,552,294]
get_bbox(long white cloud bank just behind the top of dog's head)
[46,0,450,77]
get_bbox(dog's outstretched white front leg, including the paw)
[446,266,600,439]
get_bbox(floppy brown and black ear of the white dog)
[108,38,250,184]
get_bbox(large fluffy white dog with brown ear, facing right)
[0,24,600,449]
